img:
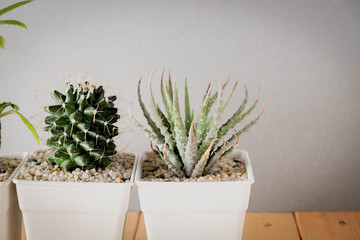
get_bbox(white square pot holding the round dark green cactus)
[14,155,136,240]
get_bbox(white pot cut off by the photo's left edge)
[0,152,27,240]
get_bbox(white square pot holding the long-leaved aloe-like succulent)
[135,150,254,240]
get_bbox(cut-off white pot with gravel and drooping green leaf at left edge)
[0,102,39,240]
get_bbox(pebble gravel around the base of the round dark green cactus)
[19,150,135,183]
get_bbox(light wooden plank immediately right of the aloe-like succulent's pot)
[242,212,300,240]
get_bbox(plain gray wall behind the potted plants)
[0,0,360,211]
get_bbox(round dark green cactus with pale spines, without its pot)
[45,81,120,170]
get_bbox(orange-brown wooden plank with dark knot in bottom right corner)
[295,212,360,240]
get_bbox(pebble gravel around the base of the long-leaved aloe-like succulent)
[141,157,248,182]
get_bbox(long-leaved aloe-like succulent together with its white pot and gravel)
[130,74,265,240]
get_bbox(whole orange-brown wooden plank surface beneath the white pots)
[22,212,360,240]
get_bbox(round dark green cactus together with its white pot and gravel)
[14,79,135,240]
